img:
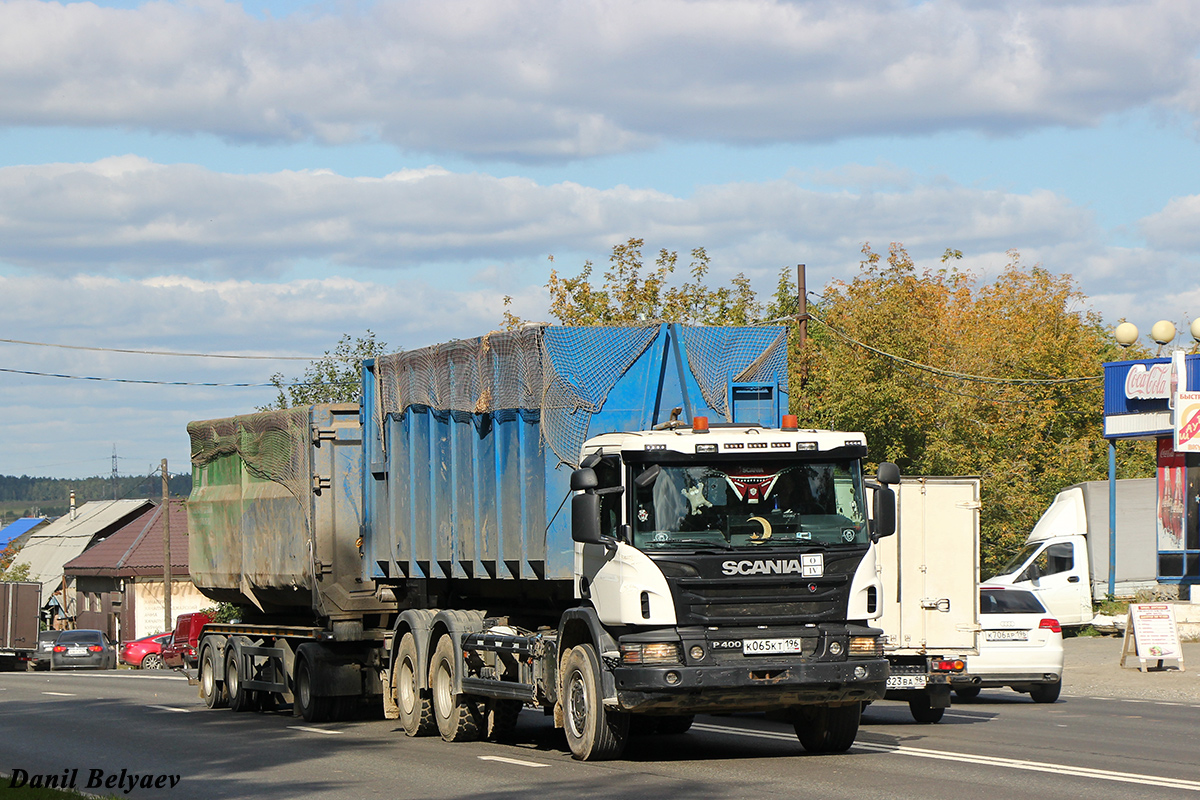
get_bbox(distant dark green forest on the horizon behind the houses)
[0,475,192,524]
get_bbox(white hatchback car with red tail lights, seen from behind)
[953,587,1062,703]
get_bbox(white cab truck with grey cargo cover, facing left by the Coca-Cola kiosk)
[988,477,1158,626]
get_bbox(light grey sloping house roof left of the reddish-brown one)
[16,500,154,600]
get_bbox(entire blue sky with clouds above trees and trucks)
[0,0,1200,477]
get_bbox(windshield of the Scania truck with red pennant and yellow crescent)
[632,458,868,551]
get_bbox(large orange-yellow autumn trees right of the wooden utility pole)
[772,245,1153,573]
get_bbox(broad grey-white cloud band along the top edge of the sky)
[0,0,1200,160]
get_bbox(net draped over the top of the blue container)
[373,323,787,467]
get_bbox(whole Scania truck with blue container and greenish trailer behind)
[188,324,899,759]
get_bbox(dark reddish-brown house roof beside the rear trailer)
[65,499,187,578]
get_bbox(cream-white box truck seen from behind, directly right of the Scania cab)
[875,476,980,722]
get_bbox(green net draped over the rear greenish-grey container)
[187,405,312,533]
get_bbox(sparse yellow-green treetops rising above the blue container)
[504,239,762,330]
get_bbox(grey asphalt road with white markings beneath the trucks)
[0,670,1200,800]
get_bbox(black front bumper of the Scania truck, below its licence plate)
[612,658,888,714]
